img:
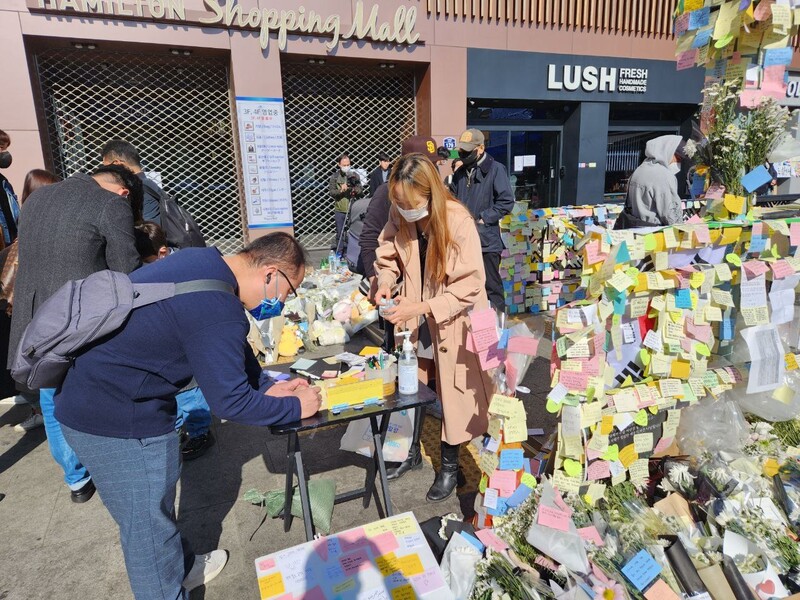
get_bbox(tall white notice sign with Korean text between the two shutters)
[236,97,293,229]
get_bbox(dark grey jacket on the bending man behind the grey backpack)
[9,173,141,364]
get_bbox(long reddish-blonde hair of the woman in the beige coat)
[389,152,460,284]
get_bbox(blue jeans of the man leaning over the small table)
[63,427,194,600]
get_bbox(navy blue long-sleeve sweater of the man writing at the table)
[55,248,300,438]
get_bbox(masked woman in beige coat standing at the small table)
[375,154,493,502]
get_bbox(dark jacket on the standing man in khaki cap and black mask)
[450,153,514,253]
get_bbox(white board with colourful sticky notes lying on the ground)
[256,512,453,600]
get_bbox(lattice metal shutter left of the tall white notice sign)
[29,43,244,252]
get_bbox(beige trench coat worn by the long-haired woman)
[375,202,494,444]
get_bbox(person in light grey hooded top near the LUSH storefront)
[614,135,686,229]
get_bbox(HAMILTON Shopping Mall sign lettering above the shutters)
[28,0,419,51]
